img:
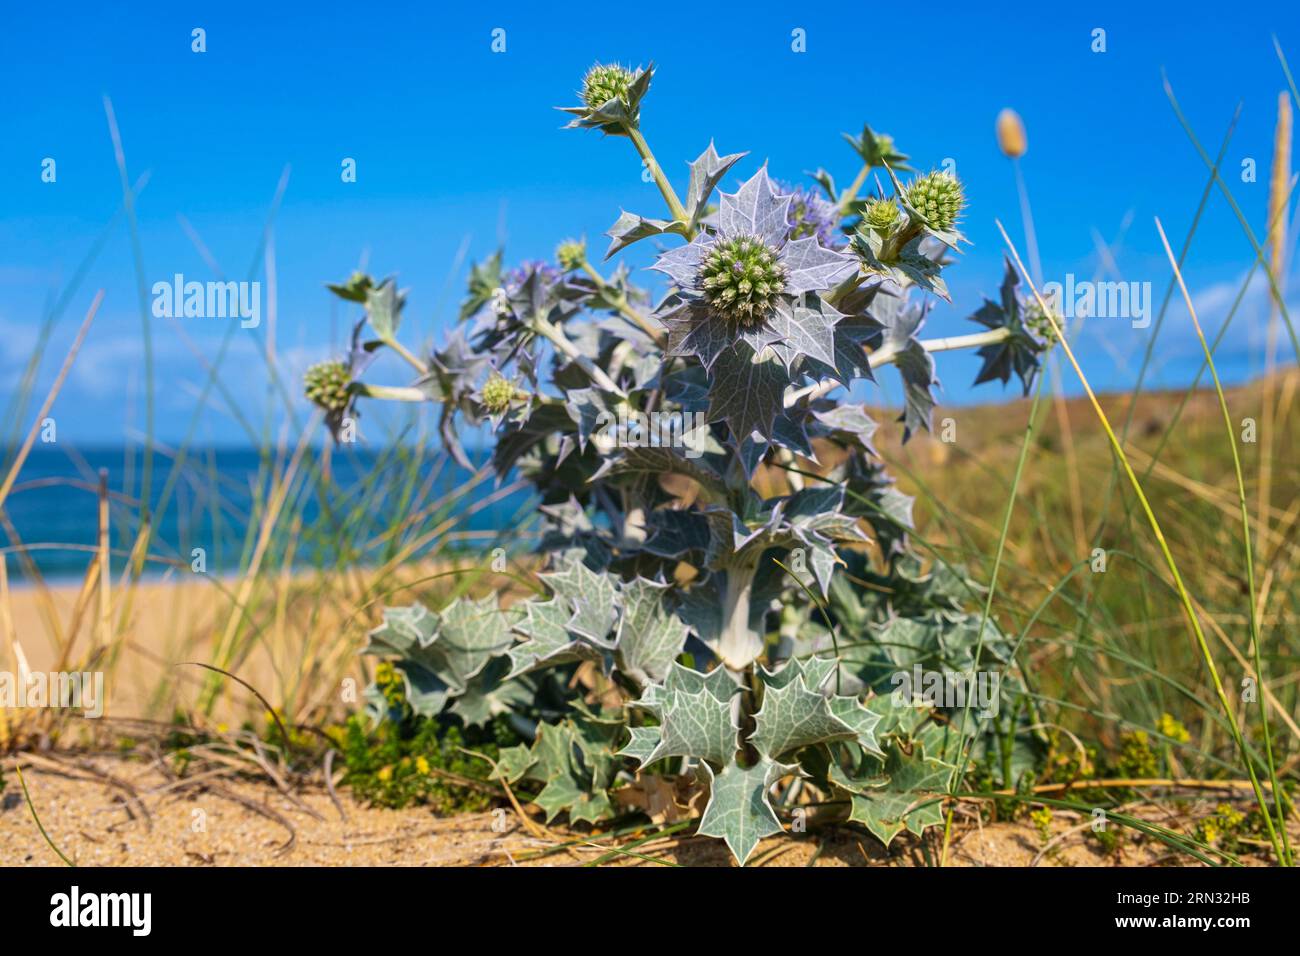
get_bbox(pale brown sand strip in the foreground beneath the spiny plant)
[0,753,1216,866]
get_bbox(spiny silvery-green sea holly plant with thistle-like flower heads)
[307,59,1050,862]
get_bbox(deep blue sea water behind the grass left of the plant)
[0,445,532,587]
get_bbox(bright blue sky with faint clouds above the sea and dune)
[0,3,1300,442]
